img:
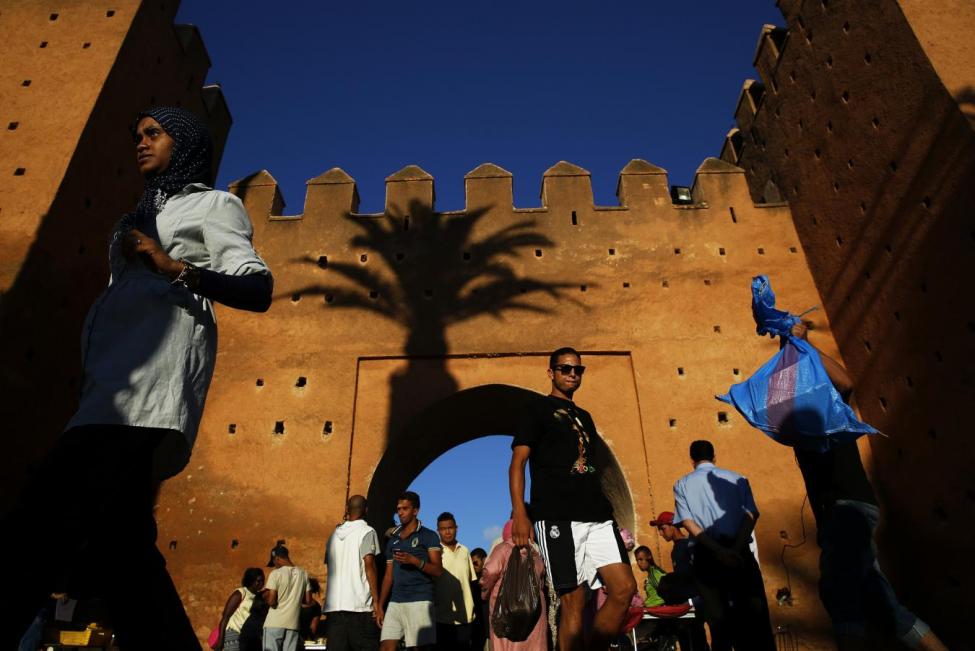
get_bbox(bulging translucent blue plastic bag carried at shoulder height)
[717,276,877,452]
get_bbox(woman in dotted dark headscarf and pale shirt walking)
[0,108,272,650]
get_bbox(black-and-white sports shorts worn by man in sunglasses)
[535,520,630,593]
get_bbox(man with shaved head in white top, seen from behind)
[325,495,383,651]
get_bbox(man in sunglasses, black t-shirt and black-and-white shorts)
[508,348,636,651]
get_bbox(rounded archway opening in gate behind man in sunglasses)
[368,384,635,546]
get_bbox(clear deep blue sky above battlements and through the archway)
[177,0,782,548]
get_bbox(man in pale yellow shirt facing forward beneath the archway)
[435,512,477,651]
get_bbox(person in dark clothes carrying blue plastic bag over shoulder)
[718,276,946,651]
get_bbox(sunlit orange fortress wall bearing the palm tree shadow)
[158,159,839,648]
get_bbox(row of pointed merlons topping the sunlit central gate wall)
[230,158,764,221]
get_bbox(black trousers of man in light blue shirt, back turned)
[694,541,775,651]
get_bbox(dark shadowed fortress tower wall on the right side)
[722,0,975,646]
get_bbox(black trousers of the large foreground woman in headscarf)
[0,425,200,651]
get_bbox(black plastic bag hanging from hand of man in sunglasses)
[491,547,542,642]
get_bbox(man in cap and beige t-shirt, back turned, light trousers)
[264,544,312,651]
